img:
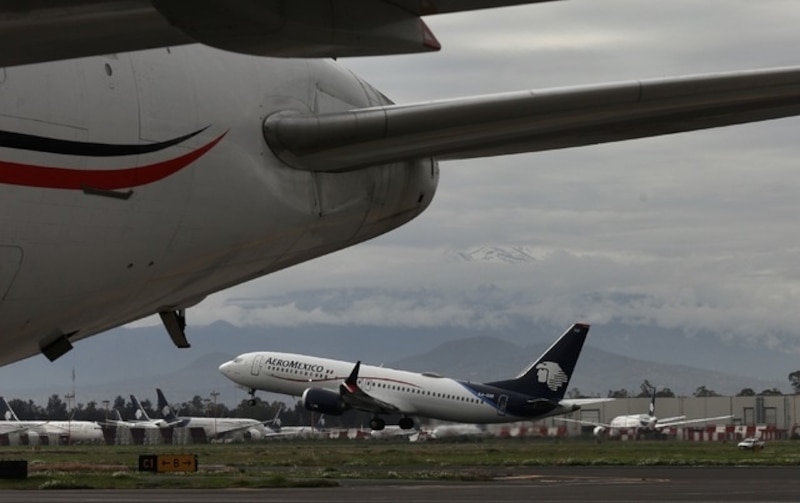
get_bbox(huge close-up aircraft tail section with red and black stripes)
[0,0,800,364]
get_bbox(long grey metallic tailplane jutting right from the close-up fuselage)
[264,67,800,172]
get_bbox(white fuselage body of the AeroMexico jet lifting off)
[225,352,536,423]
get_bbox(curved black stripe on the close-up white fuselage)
[0,126,208,157]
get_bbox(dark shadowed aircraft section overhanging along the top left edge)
[0,0,551,67]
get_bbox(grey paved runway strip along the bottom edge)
[0,466,800,503]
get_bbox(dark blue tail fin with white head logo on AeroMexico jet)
[488,323,589,402]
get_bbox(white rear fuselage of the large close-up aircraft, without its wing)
[0,45,438,364]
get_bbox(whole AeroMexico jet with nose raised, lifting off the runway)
[219,323,604,430]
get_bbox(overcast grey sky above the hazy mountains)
[133,0,800,358]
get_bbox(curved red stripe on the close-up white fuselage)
[0,131,227,190]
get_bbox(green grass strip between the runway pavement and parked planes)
[0,439,800,489]
